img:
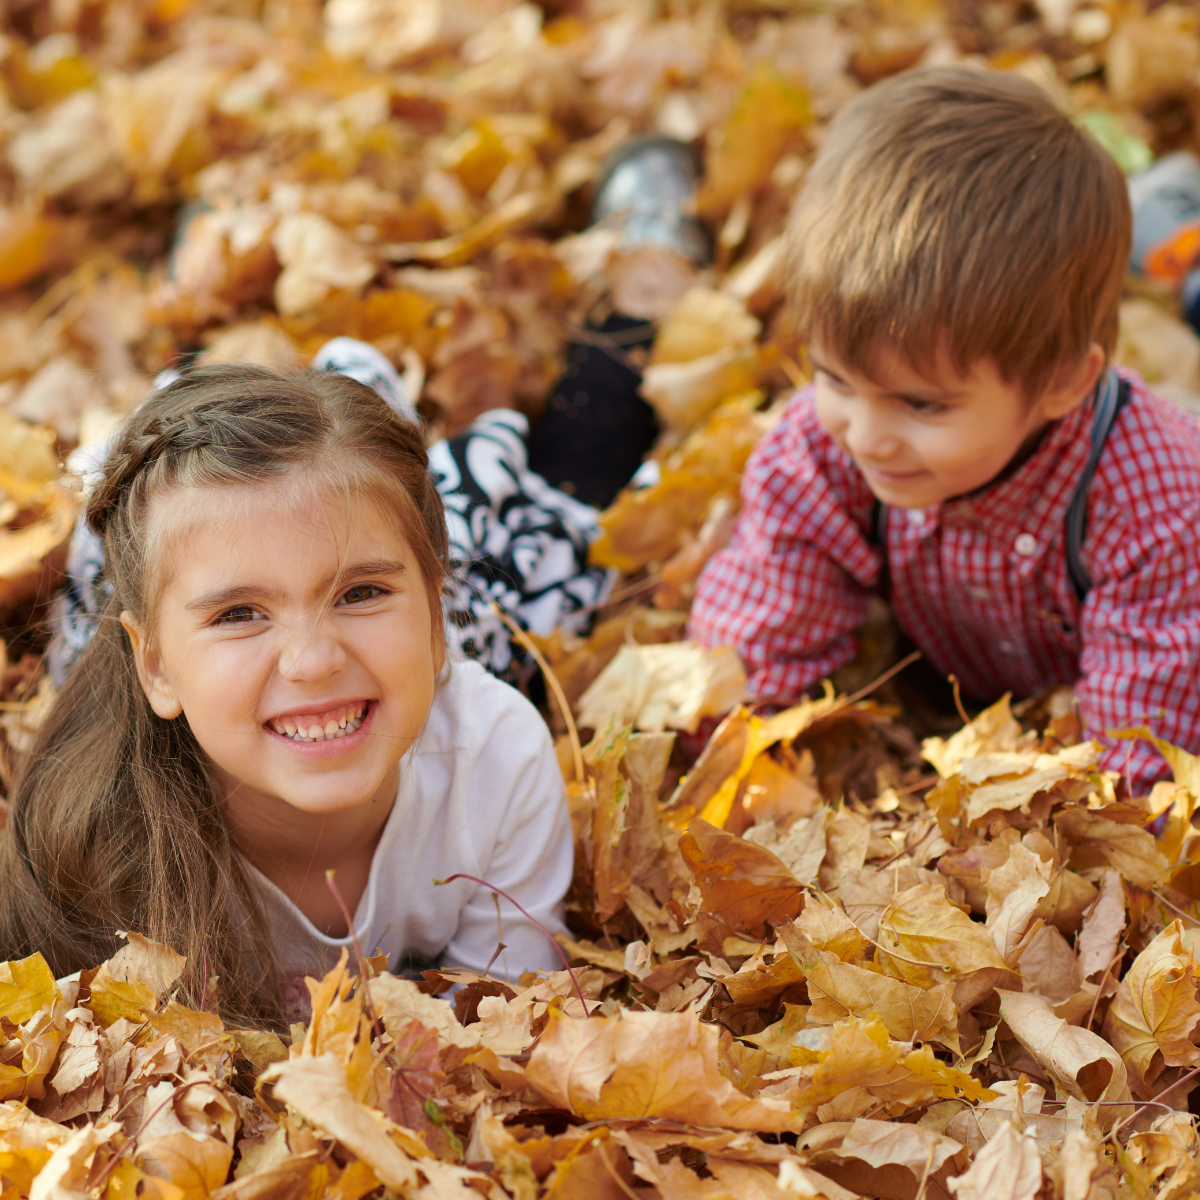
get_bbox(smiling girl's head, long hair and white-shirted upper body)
[0,366,571,1021]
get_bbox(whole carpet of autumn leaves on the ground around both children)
[0,0,1200,1200]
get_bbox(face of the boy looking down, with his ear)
[811,343,1104,509]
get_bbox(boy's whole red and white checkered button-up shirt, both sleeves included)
[691,372,1200,794]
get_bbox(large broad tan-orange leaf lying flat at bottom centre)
[526,1010,804,1132]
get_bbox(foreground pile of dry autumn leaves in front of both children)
[0,696,1200,1200]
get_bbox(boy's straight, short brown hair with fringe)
[787,67,1132,400]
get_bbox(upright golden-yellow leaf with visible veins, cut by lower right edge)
[1104,920,1200,1097]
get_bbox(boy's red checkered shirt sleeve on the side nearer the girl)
[689,390,882,701]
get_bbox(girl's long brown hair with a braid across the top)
[0,365,446,1024]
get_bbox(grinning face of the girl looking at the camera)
[122,474,440,823]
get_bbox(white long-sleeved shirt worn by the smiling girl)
[251,662,574,993]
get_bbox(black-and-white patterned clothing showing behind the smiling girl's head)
[48,337,613,683]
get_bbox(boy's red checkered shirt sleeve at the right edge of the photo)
[1075,503,1200,796]
